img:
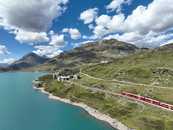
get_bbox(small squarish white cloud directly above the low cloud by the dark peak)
[49,34,65,46]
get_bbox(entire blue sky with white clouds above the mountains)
[0,0,173,63]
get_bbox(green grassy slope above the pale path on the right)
[82,44,173,87]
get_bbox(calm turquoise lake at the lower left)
[0,72,114,130]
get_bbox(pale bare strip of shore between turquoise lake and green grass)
[33,86,130,130]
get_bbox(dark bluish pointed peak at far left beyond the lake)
[0,53,48,71]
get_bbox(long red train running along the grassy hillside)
[121,92,173,110]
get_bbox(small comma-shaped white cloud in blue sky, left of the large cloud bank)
[62,28,81,40]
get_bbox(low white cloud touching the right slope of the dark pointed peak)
[33,45,63,58]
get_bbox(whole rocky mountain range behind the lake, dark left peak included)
[0,39,141,71]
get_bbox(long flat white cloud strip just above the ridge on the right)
[104,31,173,48]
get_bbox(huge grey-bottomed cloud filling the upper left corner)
[0,0,69,43]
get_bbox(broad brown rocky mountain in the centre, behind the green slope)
[40,39,140,69]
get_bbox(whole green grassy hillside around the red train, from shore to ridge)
[37,44,173,130]
